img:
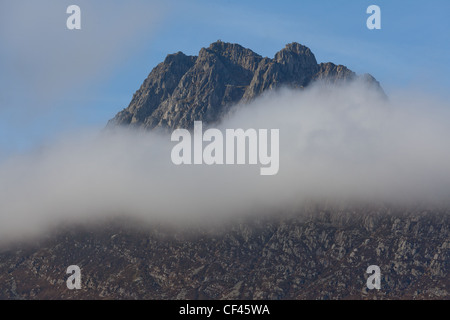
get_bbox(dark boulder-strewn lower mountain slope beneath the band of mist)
[0,206,450,299]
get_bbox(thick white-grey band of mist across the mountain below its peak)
[0,82,450,240]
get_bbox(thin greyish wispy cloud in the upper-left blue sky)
[0,0,167,116]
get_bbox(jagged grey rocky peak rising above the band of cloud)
[109,41,382,129]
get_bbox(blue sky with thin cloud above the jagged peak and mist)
[0,0,450,160]
